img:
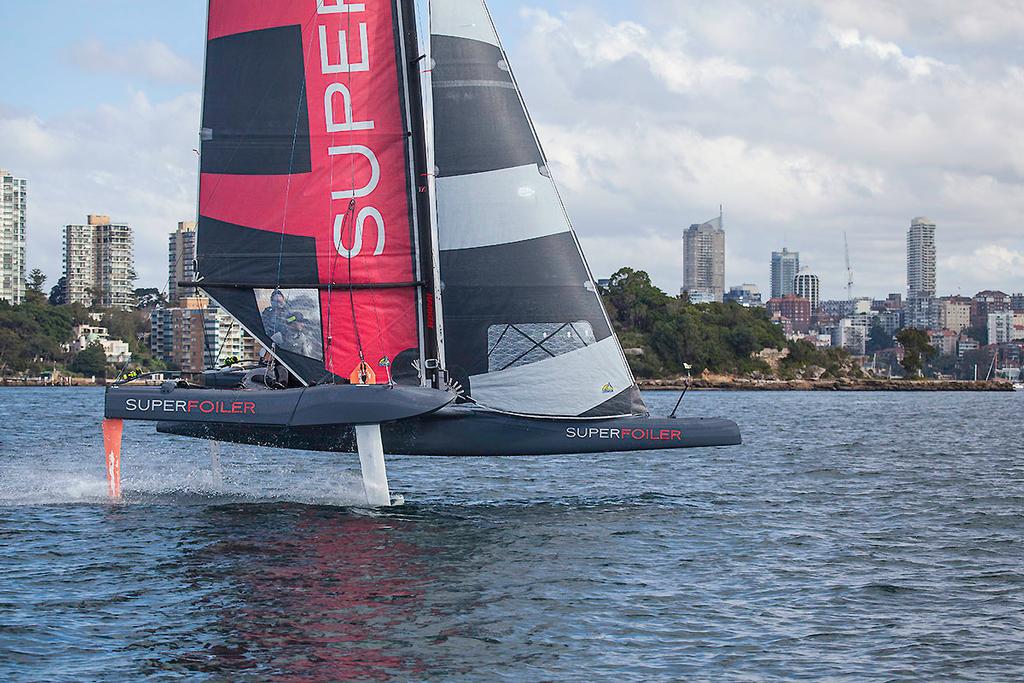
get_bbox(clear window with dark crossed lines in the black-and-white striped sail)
[487,321,597,373]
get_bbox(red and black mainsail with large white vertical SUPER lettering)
[197,0,422,384]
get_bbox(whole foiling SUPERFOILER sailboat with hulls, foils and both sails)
[103,0,740,506]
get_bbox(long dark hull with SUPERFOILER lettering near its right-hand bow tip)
[158,408,741,457]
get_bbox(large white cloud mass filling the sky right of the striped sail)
[510,0,1024,297]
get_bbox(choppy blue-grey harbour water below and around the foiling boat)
[0,389,1024,681]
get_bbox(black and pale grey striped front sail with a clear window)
[430,0,646,417]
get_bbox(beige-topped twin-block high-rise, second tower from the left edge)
[63,215,135,309]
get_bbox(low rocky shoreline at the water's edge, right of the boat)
[637,375,1014,391]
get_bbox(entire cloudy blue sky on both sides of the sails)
[0,0,1024,298]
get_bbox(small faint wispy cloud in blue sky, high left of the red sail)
[68,40,201,85]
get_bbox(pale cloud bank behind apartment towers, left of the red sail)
[0,92,200,288]
